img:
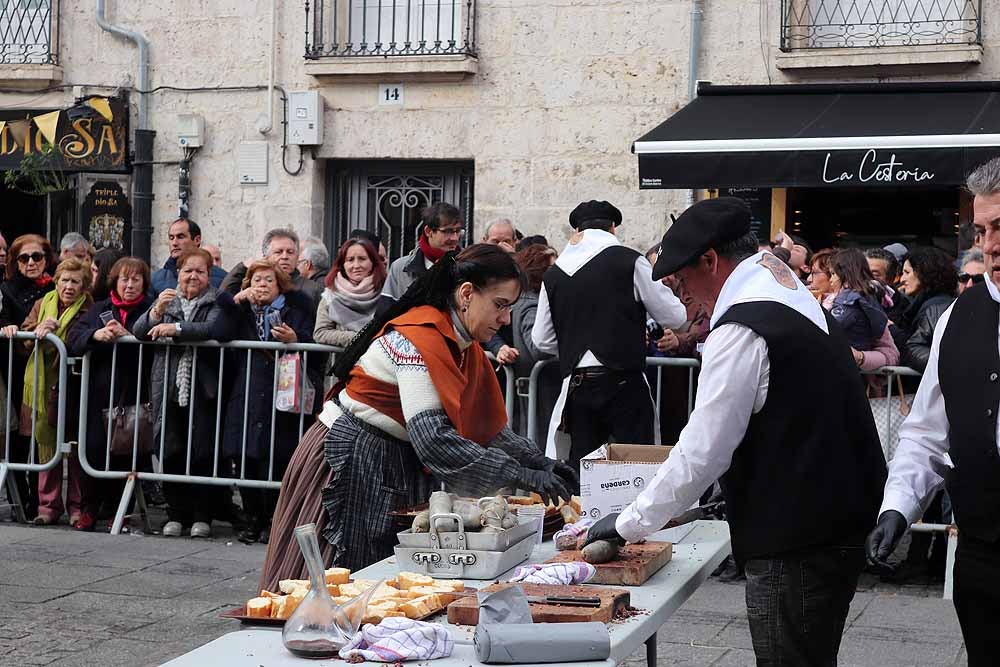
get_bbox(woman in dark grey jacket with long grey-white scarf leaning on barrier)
[133,248,233,537]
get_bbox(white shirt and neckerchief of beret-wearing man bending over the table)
[615,253,828,542]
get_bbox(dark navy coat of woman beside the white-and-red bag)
[220,290,323,470]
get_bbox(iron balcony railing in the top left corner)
[0,0,59,65]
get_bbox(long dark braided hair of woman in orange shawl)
[333,243,524,380]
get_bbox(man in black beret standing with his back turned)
[531,201,687,468]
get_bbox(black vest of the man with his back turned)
[544,246,646,377]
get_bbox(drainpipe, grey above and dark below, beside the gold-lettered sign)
[97,0,156,262]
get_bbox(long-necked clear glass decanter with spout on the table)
[281,523,382,659]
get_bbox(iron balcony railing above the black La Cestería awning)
[781,0,982,51]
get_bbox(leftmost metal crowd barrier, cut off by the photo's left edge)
[0,331,72,523]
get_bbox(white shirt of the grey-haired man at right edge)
[879,277,1000,523]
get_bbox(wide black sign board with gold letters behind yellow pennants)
[0,98,129,171]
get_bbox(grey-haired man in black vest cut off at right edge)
[866,159,1000,667]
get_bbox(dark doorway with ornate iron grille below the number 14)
[327,160,475,261]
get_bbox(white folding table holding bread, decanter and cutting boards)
[165,521,730,667]
